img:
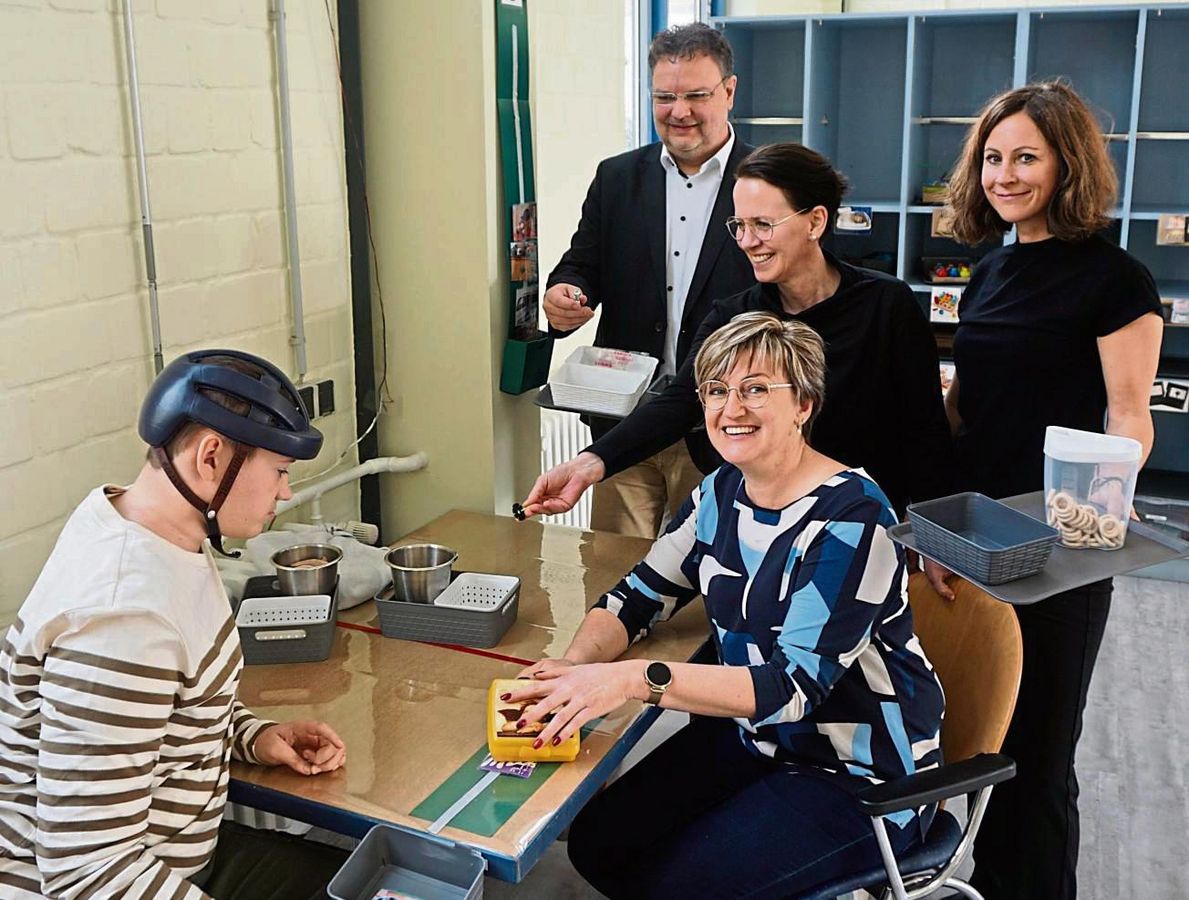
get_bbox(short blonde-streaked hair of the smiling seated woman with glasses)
[693,313,825,440]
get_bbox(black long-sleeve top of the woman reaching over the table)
[586,253,954,515]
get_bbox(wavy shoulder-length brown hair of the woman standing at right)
[949,81,1119,245]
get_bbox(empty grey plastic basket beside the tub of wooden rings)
[908,491,1058,585]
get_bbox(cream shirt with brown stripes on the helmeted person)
[0,487,269,900]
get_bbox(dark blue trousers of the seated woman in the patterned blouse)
[568,718,920,900]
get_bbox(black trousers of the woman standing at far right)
[973,579,1112,900]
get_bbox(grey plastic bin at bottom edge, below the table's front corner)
[326,825,487,900]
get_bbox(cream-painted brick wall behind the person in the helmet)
[0,0,358,622]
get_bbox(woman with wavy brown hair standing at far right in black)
[945,82,1163,900]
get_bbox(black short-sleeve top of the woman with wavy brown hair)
[954,235,1160,497]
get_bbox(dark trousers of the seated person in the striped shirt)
[191,820,347,900]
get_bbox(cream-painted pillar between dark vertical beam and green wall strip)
[360,0,540,540]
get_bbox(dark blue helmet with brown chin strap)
[138,350,322,555]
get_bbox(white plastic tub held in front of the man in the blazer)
[549,347,656,417]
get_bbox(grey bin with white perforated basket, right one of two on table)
[376,572,520,647]
